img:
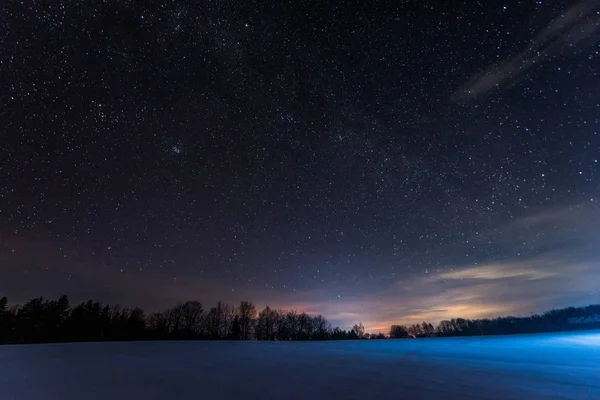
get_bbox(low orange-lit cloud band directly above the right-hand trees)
[346,257,600,331]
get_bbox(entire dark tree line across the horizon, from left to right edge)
[0,296,600,344]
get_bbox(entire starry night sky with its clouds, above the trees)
[0,0,600,330]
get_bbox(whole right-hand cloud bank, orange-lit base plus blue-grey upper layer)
[310,203,600,331]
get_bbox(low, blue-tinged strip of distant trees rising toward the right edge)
[389,305,600,338]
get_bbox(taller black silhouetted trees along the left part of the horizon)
[0,296,372,344]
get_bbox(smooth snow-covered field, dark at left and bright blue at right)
[0,331,600,400]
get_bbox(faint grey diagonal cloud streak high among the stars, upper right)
[453,0,600,100]
